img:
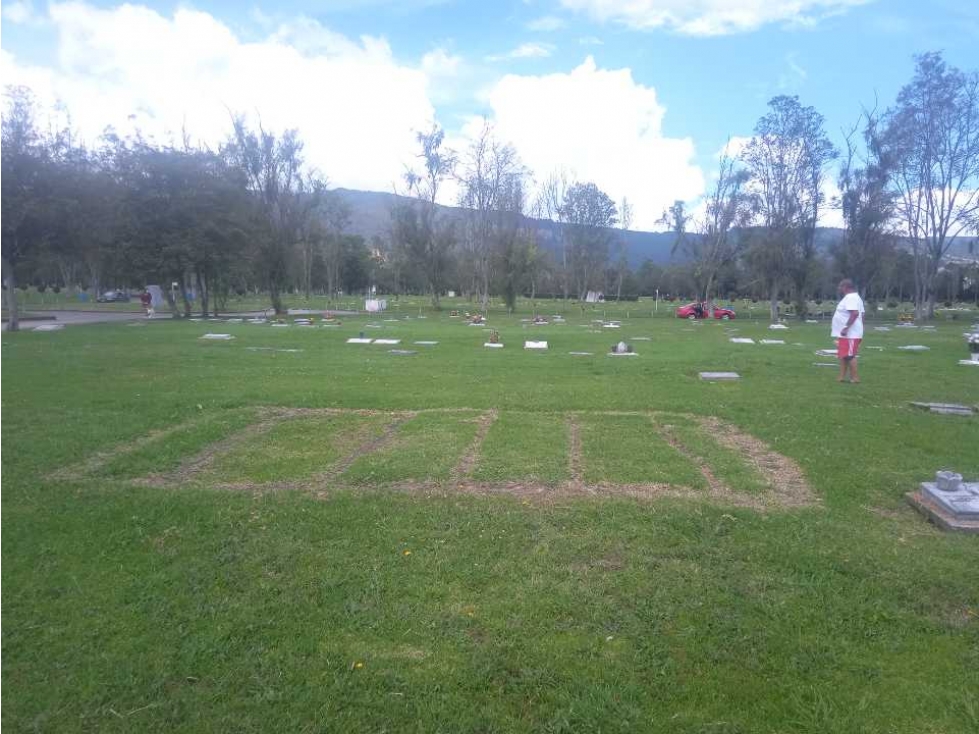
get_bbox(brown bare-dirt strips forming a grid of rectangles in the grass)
[63,407,822,512]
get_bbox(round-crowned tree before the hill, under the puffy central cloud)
[559,183,618,301]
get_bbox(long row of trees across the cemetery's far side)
[2,53,979,328]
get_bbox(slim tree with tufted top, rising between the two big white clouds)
[394,125,456,309]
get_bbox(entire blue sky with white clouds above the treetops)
[2,0,979,228]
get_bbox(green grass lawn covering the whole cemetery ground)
[2,308,979,734]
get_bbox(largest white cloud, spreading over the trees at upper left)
[0,2,436,196]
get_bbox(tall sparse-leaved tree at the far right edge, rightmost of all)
[884,53,979,319]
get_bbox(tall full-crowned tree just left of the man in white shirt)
[742,95,837,321]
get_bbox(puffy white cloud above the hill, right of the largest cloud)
[467,57,704,229]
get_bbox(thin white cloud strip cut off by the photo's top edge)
[561,0,873,36]
